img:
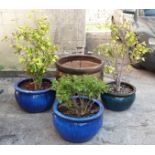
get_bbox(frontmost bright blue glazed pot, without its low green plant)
[53,96,104,143]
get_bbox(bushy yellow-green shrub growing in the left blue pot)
[6,17,57,90]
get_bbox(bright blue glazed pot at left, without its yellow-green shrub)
[15,79,56,113]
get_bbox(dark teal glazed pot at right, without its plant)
[101,82,136,111]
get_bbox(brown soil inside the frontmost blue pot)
[58,99,99,118]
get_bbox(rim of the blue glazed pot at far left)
[14,78,52,94]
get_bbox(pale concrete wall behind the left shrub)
[0,9,85,70]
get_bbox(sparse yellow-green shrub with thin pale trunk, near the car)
[95,19,151,92]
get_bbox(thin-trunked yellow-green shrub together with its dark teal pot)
[96,19,151,111]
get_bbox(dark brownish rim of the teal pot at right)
[104,81,136,97]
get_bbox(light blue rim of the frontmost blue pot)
[52,96,104,122]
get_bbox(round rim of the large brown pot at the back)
[55,55,104,74]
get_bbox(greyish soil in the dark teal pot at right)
[108,83,133,95]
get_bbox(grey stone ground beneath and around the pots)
[0,70,155,145]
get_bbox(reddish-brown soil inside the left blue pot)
[19,81,51,91]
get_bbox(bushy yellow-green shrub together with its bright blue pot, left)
[5,17,57,113]
